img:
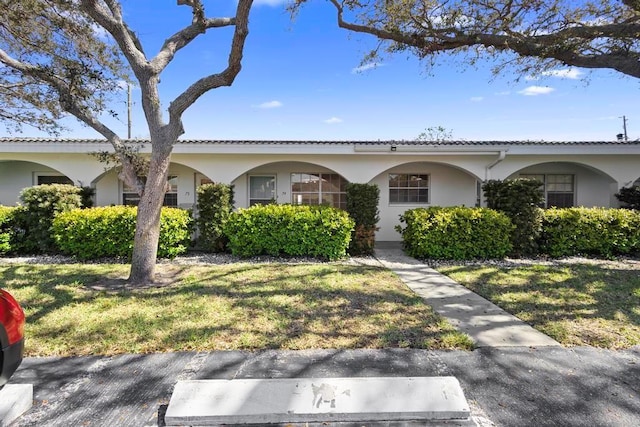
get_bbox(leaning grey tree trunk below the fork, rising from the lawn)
[128,141,172,285]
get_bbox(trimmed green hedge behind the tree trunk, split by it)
[52,206,192,259]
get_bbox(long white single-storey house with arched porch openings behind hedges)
[0,138,640,241]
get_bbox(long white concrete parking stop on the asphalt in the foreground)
[165,377,470,425]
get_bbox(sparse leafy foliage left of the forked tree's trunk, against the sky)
[0,0,126,134]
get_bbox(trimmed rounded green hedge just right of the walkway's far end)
[396,207,513,260]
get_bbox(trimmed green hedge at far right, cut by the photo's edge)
[540,208,640,257]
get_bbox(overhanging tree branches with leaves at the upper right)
[314,0,640,78]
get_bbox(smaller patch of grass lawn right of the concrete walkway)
[437,261,640,349]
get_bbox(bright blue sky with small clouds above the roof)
[2,0,640,141]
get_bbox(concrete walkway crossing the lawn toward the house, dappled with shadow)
[375,243,560,347]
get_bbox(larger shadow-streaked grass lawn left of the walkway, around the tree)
[0,263,472,356]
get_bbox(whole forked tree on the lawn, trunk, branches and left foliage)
[0,0,252,283]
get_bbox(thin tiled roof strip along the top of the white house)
[0,137,640,146]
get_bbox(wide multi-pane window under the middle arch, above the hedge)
[291,172,347,209]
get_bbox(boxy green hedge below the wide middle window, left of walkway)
[224,204,354,260]
